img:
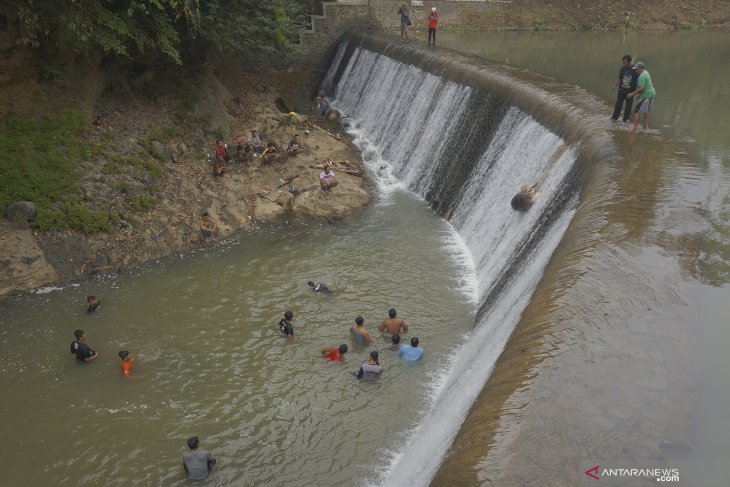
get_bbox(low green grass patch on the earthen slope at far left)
[0,110,164,233]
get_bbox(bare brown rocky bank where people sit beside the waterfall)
[0,73,371,296]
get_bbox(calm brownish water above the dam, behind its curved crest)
[433,31,730,486]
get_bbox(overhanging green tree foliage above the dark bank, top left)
[15,0,311,64]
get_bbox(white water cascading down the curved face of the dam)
[327,41,578,486]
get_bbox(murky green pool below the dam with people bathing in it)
[0,195,474,486]
